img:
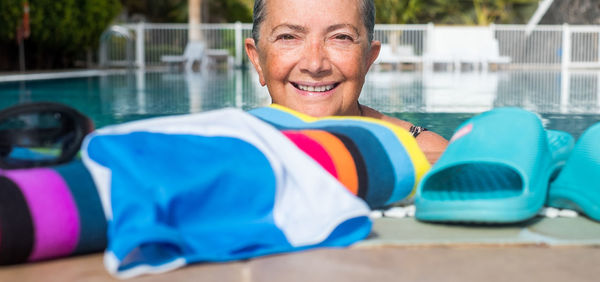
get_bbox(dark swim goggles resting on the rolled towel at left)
[0,102,94,169]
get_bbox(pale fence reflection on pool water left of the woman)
[99,70,270,124]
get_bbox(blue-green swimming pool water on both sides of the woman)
[0,70,600,138]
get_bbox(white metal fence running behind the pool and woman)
[99,23,600,69]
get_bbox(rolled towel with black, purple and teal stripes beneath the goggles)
[0,160,106,264]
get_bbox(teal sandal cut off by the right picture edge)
[548,123,600,221]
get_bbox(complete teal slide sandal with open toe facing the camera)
[415,108,574,223]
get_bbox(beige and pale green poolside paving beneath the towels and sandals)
[0,217,600,282]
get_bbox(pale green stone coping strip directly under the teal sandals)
[364,216,600,246]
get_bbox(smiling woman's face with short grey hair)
[246,0,380,116]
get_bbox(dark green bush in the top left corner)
[0,0,121,68]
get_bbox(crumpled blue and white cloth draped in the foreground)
[83,109,371,278]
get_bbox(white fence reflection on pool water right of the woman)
[361,70,600,114]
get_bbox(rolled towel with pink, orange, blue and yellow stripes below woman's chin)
[249,104,430,209]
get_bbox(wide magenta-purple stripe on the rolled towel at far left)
[5,168,79,261]
